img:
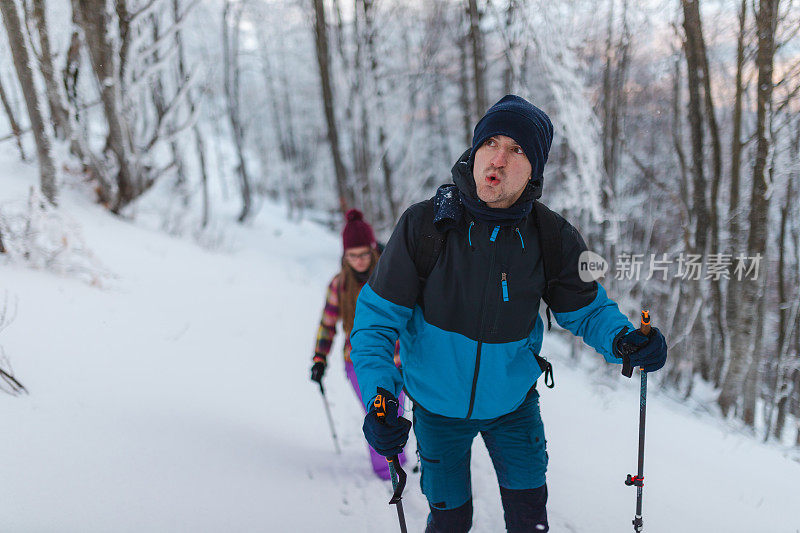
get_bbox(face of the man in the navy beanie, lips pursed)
[472,135,531,209]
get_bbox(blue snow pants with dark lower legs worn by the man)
[414,389,548,533]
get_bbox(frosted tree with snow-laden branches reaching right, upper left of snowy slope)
[68,0,194,213]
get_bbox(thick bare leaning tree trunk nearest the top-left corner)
[0,0,58,205]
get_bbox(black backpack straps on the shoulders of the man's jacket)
[414,200,562,389]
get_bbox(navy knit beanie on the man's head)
[469,94,553,184]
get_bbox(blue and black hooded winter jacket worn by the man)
[350,152,634,419]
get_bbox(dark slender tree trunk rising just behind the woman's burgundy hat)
[314,0,353,213]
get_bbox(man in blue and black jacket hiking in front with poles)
[351,95,667,533]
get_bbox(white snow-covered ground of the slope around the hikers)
[0,153,800,533]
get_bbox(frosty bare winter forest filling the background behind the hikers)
[0,0,800,447]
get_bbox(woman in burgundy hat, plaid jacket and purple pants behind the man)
[311,209,405,479]
